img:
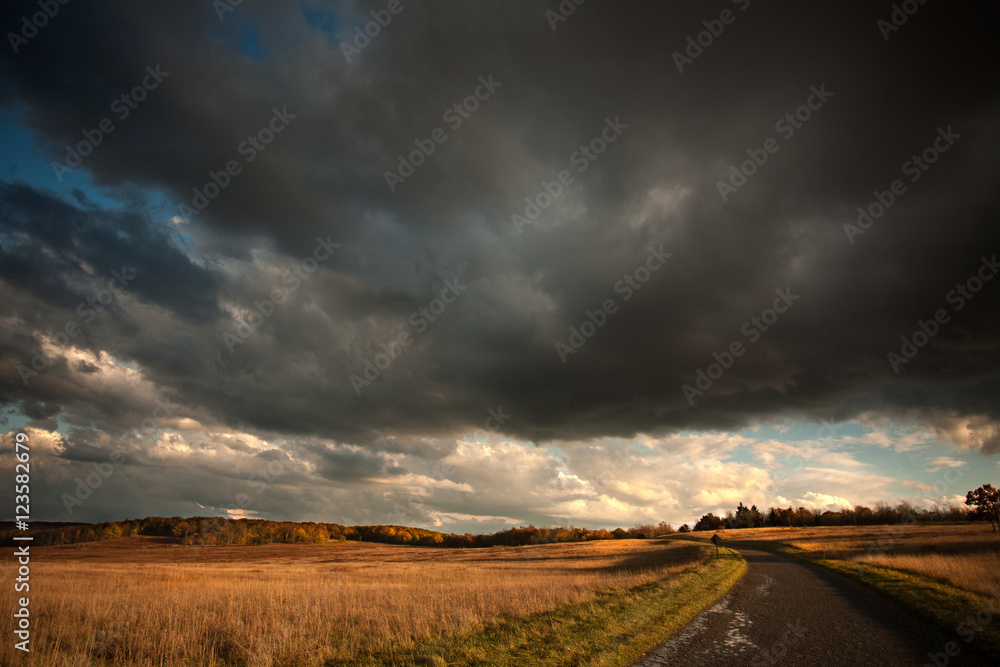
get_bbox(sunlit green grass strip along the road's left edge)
[340,549,747,667]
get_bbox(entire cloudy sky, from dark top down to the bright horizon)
[0,0,1000,532]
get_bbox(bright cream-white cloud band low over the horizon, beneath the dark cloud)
[5,418,992,532]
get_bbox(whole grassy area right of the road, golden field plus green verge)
[694,524,1000,655]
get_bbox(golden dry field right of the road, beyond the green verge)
[696,523,1000,595]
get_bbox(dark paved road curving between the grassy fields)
[636,548,996,667]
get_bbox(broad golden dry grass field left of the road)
[0,539,705,666]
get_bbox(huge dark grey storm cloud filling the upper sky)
[0,1,1000,454]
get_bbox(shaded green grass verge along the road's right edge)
[731,540,1000,657]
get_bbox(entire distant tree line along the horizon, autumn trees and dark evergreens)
[0,503,987,548]
